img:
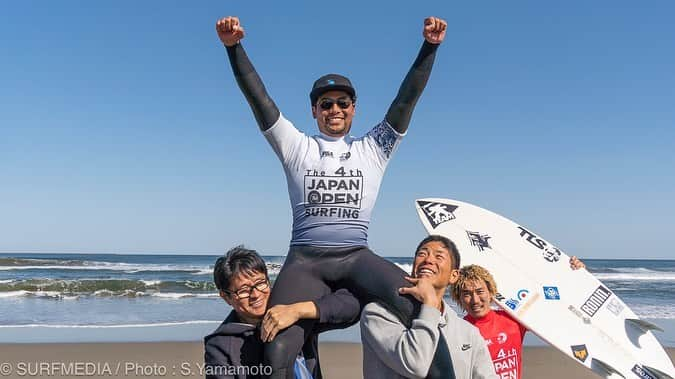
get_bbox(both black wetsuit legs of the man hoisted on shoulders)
[265,247,454,379]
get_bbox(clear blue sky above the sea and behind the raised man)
[0,0,675,258]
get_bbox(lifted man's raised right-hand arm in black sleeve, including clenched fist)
[385,17,447,133]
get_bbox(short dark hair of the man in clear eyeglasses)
[213,245,269,291]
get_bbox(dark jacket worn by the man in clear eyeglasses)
[204,289,361,379]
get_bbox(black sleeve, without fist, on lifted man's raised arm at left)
[226,43,280,131]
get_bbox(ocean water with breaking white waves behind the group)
[0,253,675,346]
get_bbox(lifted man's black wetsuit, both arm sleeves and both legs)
[227,42,454,378]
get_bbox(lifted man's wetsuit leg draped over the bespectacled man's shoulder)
[264,250,331,379]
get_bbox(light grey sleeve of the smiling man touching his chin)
[361,303,441,378]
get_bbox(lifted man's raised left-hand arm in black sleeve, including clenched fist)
[216,17,280,131]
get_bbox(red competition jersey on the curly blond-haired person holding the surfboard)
[464,310,527,379]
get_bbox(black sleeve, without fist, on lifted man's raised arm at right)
[385,41,439,134]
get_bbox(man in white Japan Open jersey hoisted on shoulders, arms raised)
[216,17,452,379]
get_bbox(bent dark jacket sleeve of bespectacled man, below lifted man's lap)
[314,288,361,333]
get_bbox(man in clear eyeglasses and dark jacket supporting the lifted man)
[204,246,360,379]
